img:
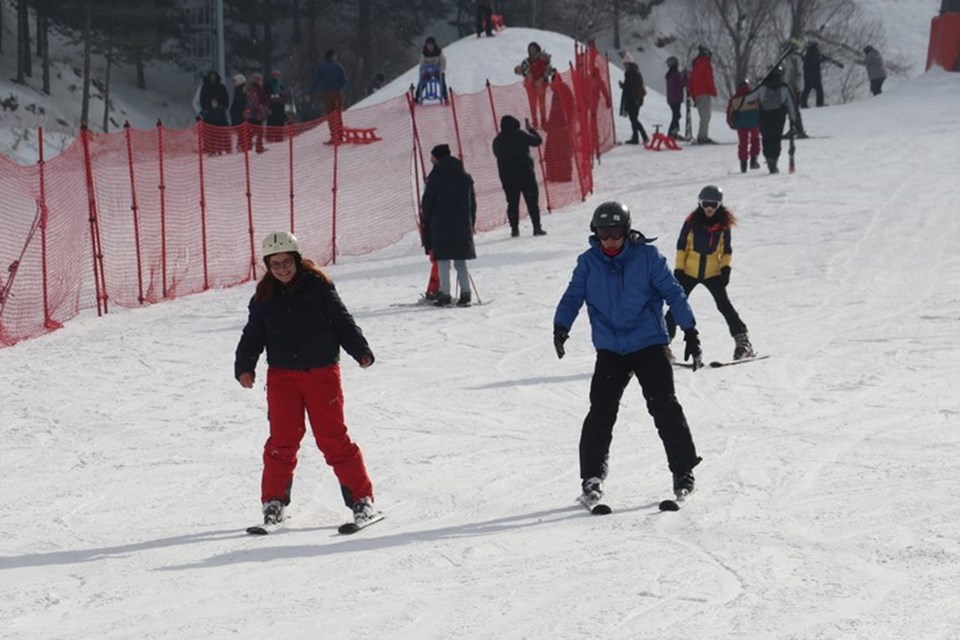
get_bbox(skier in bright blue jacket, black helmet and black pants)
[553,202,701,508]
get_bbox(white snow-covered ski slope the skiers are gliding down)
[0,5,960,640]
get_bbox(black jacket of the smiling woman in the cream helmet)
[234,269,373,378]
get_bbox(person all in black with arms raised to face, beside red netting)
[493,115,547,238]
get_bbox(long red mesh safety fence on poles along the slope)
[0,47,615,346]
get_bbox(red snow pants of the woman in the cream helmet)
[260,364,373,507]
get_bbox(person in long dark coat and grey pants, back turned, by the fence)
[420,144,477,307]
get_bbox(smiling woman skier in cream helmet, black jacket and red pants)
[234,231,379,524]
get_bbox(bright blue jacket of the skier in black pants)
[553,231,696,355]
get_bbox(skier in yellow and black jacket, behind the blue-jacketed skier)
[666,184,755,360]
